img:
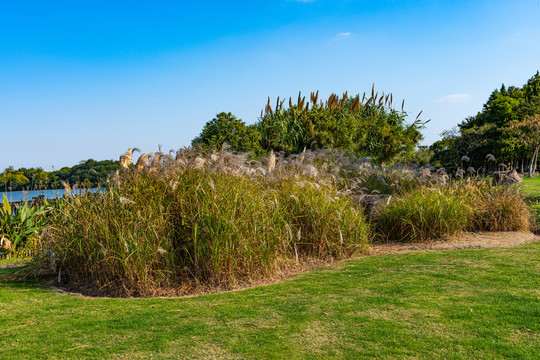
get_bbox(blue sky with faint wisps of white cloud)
[0,0,540,170]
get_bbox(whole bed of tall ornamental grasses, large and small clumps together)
[30,147,530,296]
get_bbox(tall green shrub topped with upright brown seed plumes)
[257,89,423,163]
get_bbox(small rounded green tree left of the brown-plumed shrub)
[192,112,263,154]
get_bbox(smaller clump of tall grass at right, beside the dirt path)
[377,178,531,242]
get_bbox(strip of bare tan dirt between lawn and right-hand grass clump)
[369,231,540,255]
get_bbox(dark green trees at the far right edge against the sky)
[430,72,540,175]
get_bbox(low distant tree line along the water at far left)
[0,159,118,191]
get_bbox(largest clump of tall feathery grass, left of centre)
[38,149,370,296]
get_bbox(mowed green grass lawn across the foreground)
[0,243,540,359]
